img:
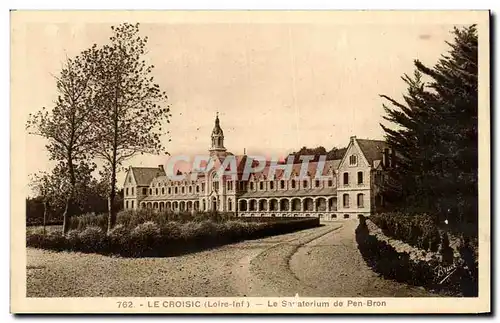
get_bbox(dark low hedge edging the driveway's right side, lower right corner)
[356,216,478,297]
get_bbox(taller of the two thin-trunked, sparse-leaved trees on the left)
[93,23,171,230]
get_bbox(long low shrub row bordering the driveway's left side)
[27,218,319,257]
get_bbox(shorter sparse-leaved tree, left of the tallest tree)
[26,45,102,233]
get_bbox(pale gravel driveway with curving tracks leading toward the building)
[27,220,440,297]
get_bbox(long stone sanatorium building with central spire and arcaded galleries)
[124,116,393,220]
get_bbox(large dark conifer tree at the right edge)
[382,25,478,232]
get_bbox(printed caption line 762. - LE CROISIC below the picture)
[122,299,387,308]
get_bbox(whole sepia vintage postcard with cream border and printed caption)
[11,11,491,314]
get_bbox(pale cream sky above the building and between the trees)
[12,15,453,186]
